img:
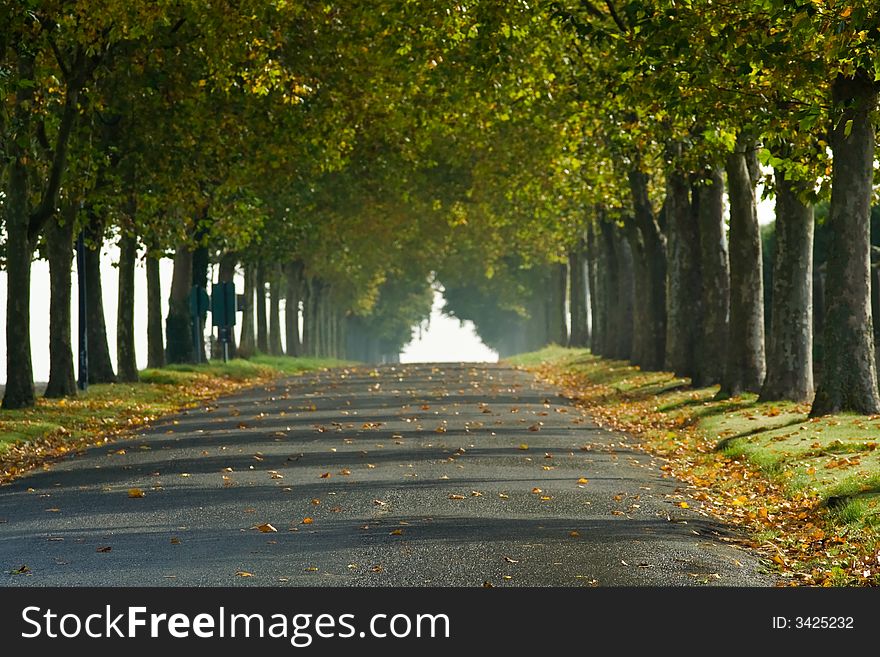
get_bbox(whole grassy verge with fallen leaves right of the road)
[510,347,880,586]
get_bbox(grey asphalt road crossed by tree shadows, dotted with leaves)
[0,365,772,586]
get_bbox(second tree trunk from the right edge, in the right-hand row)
[760,170,814,402]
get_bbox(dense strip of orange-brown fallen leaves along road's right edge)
[534,363,880,586]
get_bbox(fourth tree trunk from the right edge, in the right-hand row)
[693,168,730,386]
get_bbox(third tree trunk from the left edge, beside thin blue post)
[85,216,116,383]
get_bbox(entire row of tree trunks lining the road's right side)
[564,75,880,415]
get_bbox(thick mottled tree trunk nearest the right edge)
[810,69,880,416]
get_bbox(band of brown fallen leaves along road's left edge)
[0,374,272,485]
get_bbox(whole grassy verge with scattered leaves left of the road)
[0,356,348,484]
